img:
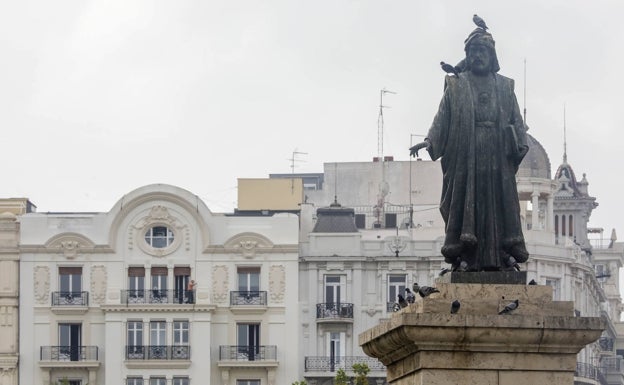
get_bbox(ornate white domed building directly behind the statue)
[298,137,624,385]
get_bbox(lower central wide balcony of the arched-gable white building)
[126,345,191,369]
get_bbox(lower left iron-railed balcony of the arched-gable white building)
[39,346,100,368]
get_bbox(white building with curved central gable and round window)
[14,185,299,385]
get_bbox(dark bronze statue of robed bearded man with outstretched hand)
[410,21,529,271]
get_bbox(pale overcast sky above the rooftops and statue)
[0,0,624,240]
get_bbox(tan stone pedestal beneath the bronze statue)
[359,283,605,385]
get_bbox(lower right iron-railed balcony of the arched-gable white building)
[218,345,278,367]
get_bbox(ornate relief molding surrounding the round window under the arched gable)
[128,205,191,257]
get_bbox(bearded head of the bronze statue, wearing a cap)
[464,28,500,75]
